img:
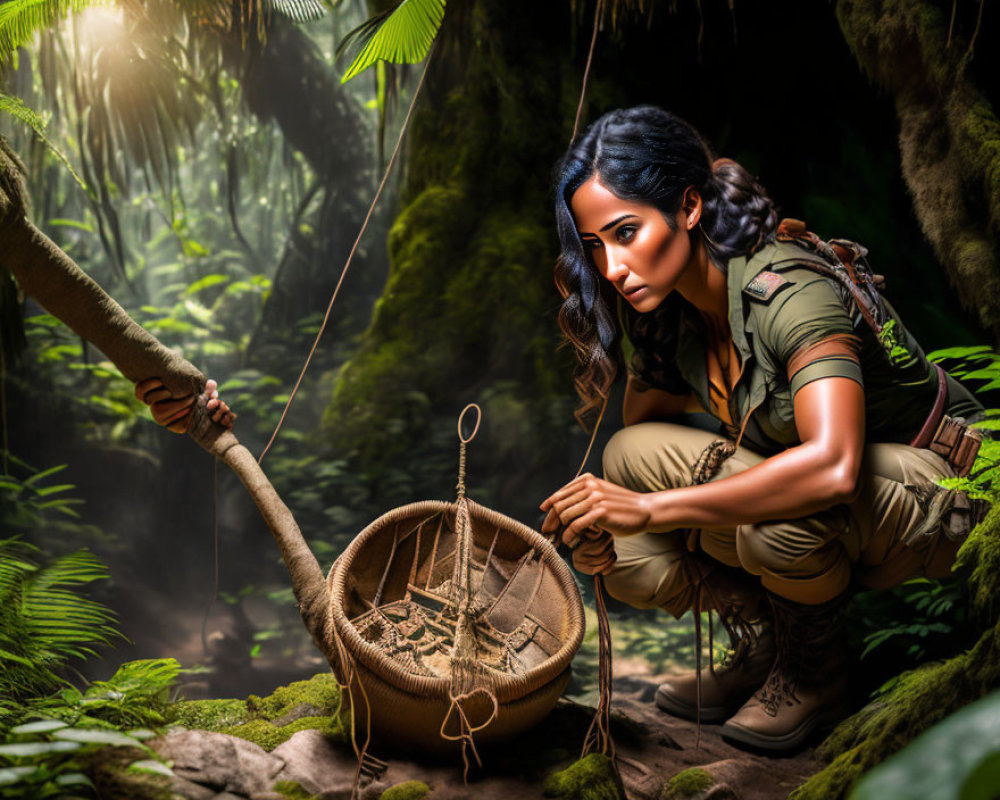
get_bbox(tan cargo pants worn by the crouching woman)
[604,422,971,617]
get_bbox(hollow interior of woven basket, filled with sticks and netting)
[345,506,567,679]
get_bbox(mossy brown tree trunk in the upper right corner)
[837,0,1000,341]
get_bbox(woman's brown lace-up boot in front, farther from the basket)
[721,594,847,752]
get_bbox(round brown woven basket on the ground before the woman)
[328,500,584,751]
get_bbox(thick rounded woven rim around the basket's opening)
[327,499,584,703]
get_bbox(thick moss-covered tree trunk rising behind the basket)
[325,0,586,508]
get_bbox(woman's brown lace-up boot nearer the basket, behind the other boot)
[655,570,775,725]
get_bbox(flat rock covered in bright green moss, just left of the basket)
[167,673,350,751]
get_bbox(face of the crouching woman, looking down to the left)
[570,175,701,312]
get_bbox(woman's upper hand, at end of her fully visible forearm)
[541,473,650,547]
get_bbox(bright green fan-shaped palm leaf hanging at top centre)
[338,0,445,83]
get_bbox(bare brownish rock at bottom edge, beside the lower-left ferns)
[151,731,285,797]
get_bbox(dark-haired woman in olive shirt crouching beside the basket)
[542,107,982,750]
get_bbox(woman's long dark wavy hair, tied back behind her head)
[555,111,777,427]
